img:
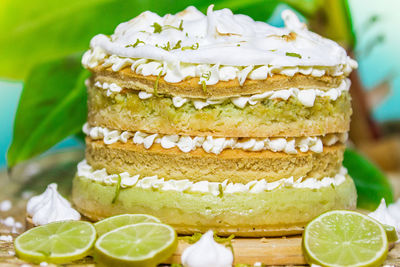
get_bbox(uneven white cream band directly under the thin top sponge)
[94,79,351,110]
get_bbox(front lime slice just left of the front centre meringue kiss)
[95,223,178,267]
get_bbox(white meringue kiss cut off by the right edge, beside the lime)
[368,198,400,235]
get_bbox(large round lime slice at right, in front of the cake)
[303,210,388,266]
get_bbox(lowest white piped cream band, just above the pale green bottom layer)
[78,160,347,196]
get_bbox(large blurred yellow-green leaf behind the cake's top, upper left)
[0,0,225,79]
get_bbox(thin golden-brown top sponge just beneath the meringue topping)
[92,66,344,98]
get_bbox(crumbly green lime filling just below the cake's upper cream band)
[89,88,351,128]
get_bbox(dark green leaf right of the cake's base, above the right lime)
[343,148,394,210]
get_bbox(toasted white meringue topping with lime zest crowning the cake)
[82,5,357,85]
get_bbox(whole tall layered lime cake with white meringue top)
[73,5,357,236]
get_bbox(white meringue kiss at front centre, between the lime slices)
[181,231,233,267]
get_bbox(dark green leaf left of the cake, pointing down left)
[7,54,89,167]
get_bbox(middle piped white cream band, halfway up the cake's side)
[82,123,348,154]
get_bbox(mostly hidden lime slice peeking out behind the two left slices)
[94,214,160,236]
